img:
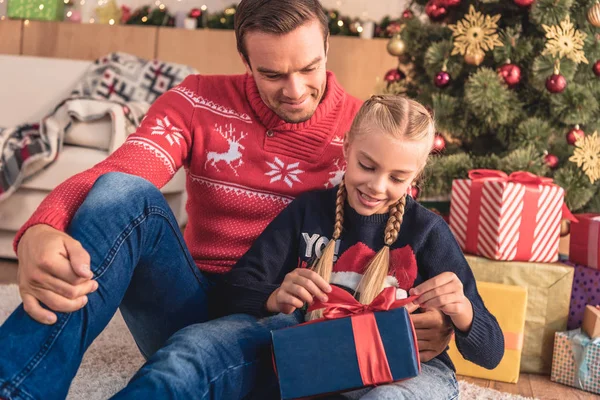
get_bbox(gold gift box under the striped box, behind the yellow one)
[466,255,574,374]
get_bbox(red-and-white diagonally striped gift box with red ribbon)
[450,170,572,262]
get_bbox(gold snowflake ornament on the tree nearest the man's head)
[448,5,503,61]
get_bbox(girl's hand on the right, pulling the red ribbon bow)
[409,272,473,332]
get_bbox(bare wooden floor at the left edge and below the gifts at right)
[0,259,600,400]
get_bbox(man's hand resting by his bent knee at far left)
[17,225,98,325]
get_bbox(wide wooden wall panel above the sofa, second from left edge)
[23,21,158,60]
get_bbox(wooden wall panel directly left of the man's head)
[156,28,245,75]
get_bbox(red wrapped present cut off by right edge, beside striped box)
[569,214,600,269]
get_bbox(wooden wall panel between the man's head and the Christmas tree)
[327,36,398,100]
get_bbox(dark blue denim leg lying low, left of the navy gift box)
[113,312,303,400]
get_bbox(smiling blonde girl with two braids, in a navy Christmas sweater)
[214,96,504,399]
